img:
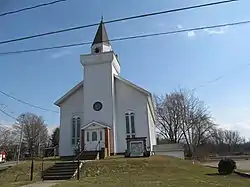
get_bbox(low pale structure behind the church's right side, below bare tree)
[153,144,185,159]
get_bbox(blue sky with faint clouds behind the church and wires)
[0,0,250,137]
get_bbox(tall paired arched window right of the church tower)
[125,112,135,138]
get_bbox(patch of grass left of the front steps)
[0,161,55,187]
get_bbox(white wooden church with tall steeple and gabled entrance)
[55,21,156,156]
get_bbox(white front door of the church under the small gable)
[84,128,105,151]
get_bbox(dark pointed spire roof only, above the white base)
[92,19,110,46]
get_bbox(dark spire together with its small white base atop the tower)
[91,19,112,54]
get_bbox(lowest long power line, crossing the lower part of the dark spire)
[0,20,250,56]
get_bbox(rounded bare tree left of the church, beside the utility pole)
[14,113,48,154]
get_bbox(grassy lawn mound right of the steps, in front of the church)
[57,156,250,187]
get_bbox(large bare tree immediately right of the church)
[156,90,215,154]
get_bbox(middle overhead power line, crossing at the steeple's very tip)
[0,0,239,44]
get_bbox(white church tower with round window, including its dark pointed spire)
[81,20,120,153]
